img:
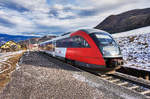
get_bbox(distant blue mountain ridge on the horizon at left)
[0,34,35,45]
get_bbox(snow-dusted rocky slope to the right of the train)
[113,27,150,71]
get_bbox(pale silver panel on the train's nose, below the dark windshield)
[102,46,119,56]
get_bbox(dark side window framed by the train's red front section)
[72,36,90,48]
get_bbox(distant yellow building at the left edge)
[0,41,21,52]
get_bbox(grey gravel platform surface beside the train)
[0,52,104,99]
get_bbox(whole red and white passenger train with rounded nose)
[39,29,123,73]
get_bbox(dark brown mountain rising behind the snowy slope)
[95,8,150,34]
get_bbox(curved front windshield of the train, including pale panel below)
[91,33,121,57]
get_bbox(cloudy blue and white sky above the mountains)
[0,0,150,36]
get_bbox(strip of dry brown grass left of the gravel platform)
[0,53,23,91]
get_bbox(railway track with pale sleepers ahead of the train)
[80,68,150,99]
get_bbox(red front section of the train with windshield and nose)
[65,29,123,71]
